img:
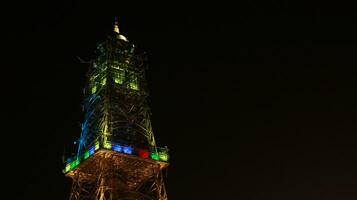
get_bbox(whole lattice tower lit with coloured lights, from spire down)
[64,22,168,200]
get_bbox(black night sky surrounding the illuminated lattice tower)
[0,0,357,200]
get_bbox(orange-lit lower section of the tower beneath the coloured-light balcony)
[66,149,168,200]
